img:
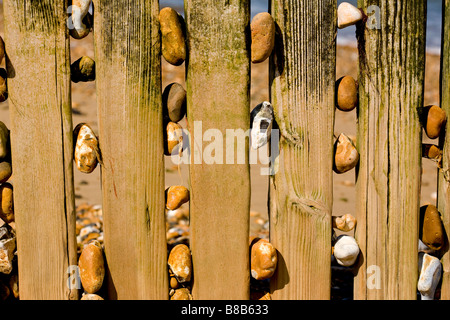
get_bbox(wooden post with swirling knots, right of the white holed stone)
[269,0,336,300]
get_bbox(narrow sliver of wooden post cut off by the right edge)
[438,0,450,300]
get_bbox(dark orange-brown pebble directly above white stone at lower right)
[419,205,445,250]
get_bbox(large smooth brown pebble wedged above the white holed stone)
[250,12,275,63]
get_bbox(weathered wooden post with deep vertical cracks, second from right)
[354,0,426,300]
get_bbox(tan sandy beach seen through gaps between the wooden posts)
[0,6,440,236]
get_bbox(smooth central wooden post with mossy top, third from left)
[185,0,250,299]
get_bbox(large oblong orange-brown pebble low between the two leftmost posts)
[78,241,105,293]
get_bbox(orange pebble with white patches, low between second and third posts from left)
[168,244,192,283]
